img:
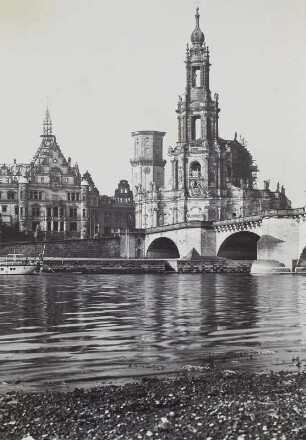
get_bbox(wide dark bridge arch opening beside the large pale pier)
[217,231,260,260]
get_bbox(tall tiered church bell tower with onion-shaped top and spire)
[170,8,223,198]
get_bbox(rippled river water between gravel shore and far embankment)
[0,274,306,392]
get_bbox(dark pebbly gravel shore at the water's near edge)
[0,368,306,440]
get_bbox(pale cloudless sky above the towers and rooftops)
[0,0,306,206]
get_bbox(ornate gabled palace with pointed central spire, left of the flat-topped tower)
[0,109,134,239]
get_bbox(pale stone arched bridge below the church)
[144,208,306,267]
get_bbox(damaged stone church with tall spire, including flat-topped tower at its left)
[131,8,291,228]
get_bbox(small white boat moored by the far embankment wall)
[0,254,43,275]
